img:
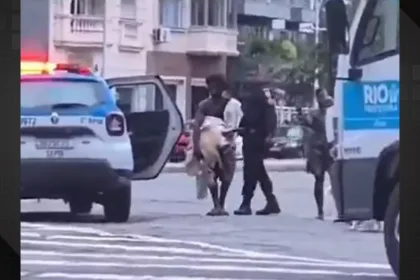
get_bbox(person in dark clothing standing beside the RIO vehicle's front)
[300,89,334,220]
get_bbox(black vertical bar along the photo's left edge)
[0,0,20,279]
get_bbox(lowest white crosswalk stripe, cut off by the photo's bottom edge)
[35,272,275,280]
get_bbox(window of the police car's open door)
[115,84,163,113]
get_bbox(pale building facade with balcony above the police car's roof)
[49,0,145,77]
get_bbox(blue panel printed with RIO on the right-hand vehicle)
[342,81,400,130]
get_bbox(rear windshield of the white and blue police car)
[20,80,106,109]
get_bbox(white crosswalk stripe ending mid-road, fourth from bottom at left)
[20,239,237,257]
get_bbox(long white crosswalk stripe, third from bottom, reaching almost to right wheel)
[21,250,390,270]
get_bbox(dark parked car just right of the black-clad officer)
[268,125,304,159]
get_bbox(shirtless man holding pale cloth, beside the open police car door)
[192,74,236,216]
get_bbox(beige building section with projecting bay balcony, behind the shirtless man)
[147,0,239,119]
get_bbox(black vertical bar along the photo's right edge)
[395,0,420,280]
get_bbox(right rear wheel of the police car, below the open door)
[103,184,131,223]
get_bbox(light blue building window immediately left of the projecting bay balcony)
[159,0,184,27]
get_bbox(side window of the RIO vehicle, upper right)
[353,0,400,65]
